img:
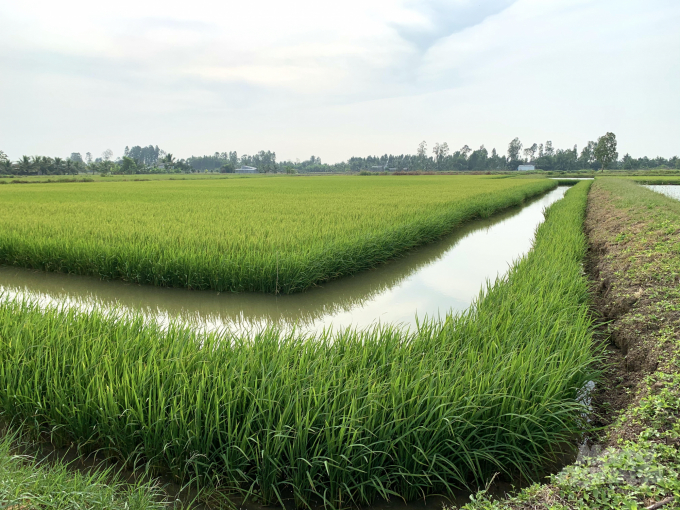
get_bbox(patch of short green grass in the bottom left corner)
[0,435,169,510]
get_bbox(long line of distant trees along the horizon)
[0,133,680,175]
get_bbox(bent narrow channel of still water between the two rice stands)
[0,186,568,332]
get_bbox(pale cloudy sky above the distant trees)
[0,0,680,163]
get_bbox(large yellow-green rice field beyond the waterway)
[0,176,556,293]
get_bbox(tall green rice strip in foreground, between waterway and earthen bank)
[0,181,597,508]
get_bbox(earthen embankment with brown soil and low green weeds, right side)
[454,179,680,510]
